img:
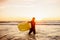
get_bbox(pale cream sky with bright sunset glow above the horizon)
[0,0,60,20]
